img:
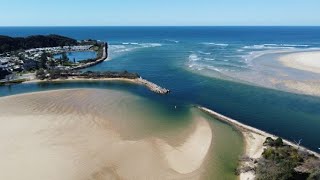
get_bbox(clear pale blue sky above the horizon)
[0,0,320,26]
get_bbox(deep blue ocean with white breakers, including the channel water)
[0,27,320,152]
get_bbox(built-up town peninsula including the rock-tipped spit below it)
[0,35,170,94]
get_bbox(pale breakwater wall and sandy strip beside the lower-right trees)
[197,106,320,180]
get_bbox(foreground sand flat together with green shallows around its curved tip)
[0,89,243,179]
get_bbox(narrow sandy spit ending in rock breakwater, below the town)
[23,77,170,95]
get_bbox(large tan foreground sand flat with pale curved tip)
[0,89,213,180]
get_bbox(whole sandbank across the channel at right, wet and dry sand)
[239,49,320,96]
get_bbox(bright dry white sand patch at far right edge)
[279,51,320,73]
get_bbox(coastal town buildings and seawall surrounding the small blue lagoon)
[0,35,108,82]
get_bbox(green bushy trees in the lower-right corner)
[256,137,320,180]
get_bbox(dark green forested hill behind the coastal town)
[0,35,78,54]
